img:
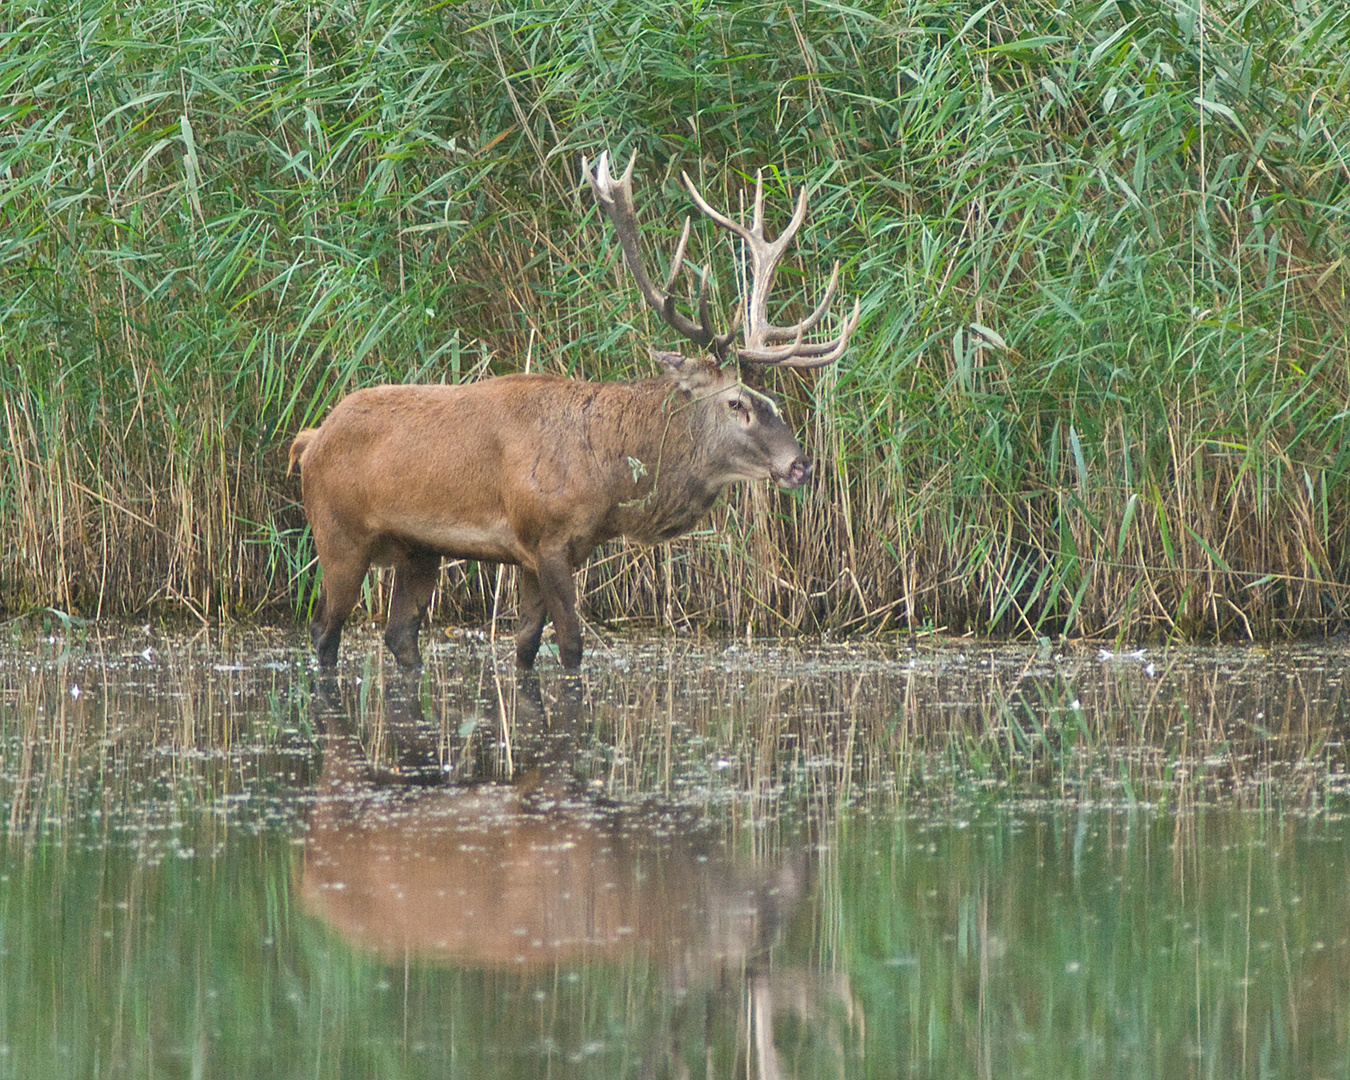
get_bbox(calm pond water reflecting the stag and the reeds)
[0,630,1350,1080]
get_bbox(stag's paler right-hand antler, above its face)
[680,173,860,367]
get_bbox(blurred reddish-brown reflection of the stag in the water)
[300,675,853,1076]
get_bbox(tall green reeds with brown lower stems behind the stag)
[0,0,1350,640]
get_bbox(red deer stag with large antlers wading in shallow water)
[290,154,859,668]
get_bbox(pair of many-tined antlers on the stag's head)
[582,150,860,367]
